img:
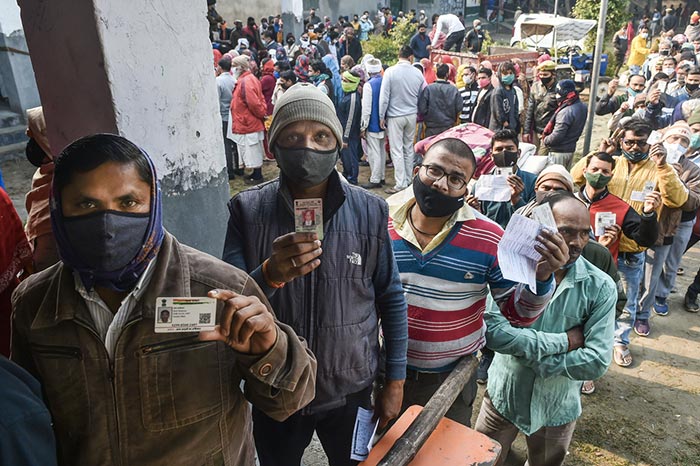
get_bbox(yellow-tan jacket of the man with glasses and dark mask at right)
[571,156,688,253]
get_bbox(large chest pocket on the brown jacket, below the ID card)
[138,337,223,432]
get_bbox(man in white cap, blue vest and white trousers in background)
[360,58,386,189]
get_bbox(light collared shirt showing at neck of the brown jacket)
[73,257,157,359]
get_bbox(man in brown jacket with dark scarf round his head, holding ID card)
[12,134,316,466]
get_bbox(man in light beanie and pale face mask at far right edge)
[640,121,700,316]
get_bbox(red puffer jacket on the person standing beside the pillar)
[231,71,267,134]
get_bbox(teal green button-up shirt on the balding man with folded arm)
[484,257,617,435]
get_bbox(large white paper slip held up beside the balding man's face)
[498,214,544,290]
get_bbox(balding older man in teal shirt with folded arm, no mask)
[476,192,617,466]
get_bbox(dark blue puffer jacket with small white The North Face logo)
[223,170,408,414]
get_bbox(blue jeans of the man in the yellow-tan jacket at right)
[615,252,648,345]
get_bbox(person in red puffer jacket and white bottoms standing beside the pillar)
[231,55,267,184]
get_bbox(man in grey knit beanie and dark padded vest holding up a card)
[223,83,407,466]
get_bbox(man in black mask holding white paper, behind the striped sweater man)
[474,129,537,228]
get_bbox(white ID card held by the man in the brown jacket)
[155,297,216,333]
